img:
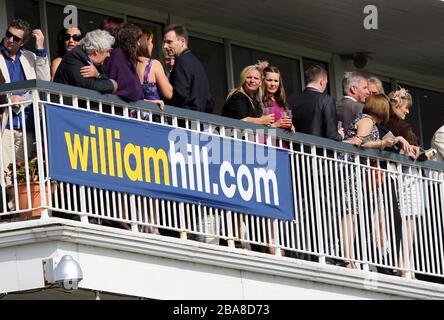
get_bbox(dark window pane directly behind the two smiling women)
[231,45,302,105]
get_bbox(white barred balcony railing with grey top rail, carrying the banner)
[0,80,444,277]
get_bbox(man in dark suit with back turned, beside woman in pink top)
[293,65,344,141]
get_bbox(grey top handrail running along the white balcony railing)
[0,80,444,171]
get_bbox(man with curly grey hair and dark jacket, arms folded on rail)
[54,30,117,93]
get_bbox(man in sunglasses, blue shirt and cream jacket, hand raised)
[0,19,51,182]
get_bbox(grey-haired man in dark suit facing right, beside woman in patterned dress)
[336,71,370,131]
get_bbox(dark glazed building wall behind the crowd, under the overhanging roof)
[4,0,444,147]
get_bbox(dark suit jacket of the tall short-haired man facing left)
[166,49,214,113]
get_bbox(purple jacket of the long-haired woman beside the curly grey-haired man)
[105,48,143,101]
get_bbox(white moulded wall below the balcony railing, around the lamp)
[4,218,444,300]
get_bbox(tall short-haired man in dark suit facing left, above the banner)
[163,25,214,113]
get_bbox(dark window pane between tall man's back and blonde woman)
[189,37,227,114]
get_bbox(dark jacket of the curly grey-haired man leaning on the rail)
[54,46,114,93]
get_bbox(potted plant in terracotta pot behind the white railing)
[6,157,53,217]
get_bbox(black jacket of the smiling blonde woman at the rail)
[222,91,262,120]
